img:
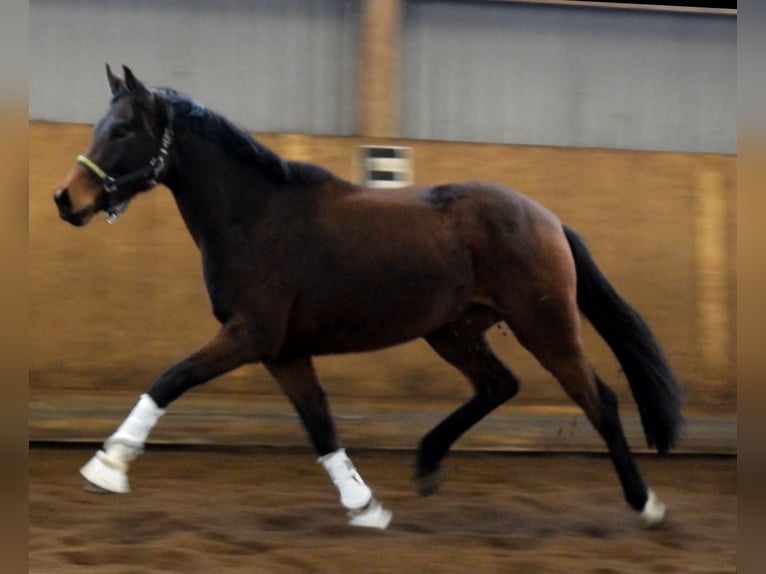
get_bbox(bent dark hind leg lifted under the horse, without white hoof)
[415,308,519,496]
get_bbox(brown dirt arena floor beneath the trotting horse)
[29,447,737,574]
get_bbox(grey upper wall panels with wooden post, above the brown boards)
[29,0,737,154]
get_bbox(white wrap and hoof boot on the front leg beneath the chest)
[318,448,391,529]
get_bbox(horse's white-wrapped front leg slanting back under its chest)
[264,357,391,529]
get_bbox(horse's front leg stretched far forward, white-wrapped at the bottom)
[80,321,257,494]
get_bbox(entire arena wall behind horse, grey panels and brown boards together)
[29,0,737,451]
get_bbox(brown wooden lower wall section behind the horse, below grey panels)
[29,123,736,412]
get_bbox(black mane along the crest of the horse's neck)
[155,88,336,185]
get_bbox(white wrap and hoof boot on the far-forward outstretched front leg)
[80,395,165,493]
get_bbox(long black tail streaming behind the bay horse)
[564,226,683,453]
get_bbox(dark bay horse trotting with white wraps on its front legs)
[54,66,682,528]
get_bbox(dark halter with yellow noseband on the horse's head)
[77,99,173,224]
